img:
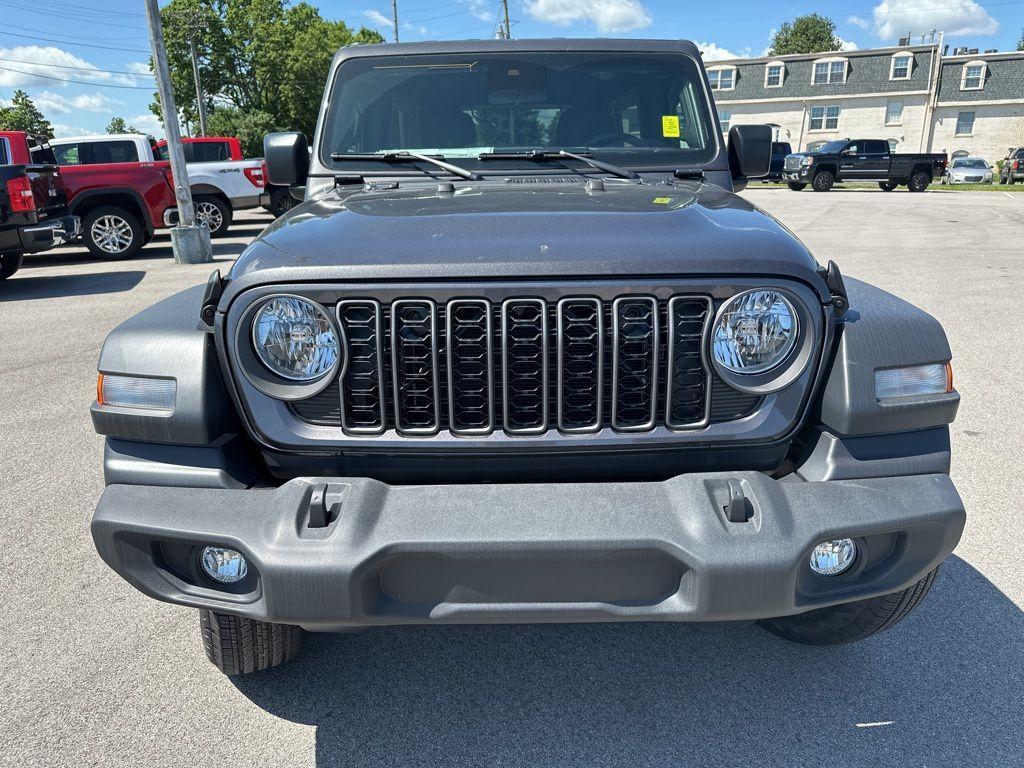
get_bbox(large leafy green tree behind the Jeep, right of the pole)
[151,0,383,143]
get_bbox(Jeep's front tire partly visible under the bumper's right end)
[758,568,939,645]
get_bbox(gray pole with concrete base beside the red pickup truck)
[144,0,213,264]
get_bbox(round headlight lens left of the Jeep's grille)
[253,296,340,381]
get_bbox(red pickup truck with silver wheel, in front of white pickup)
[33,138,177,259]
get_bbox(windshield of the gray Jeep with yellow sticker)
[321,52,718,170]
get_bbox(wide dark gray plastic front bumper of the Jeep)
[92,472,965,631]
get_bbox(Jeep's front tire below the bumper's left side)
[199,609,302,675]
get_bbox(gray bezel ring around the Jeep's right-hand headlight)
[706,287,815,394]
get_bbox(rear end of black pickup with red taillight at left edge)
[0,131,79,280]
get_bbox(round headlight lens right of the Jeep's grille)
[712,290,797,374]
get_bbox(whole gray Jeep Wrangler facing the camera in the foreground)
[92,40,965,674]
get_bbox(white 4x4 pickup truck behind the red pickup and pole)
[50,133,265,238]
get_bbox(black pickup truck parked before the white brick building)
[782,138,947,191]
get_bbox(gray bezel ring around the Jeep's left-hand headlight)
[234,293,348,400]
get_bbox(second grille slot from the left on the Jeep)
[390,299,440,434]
